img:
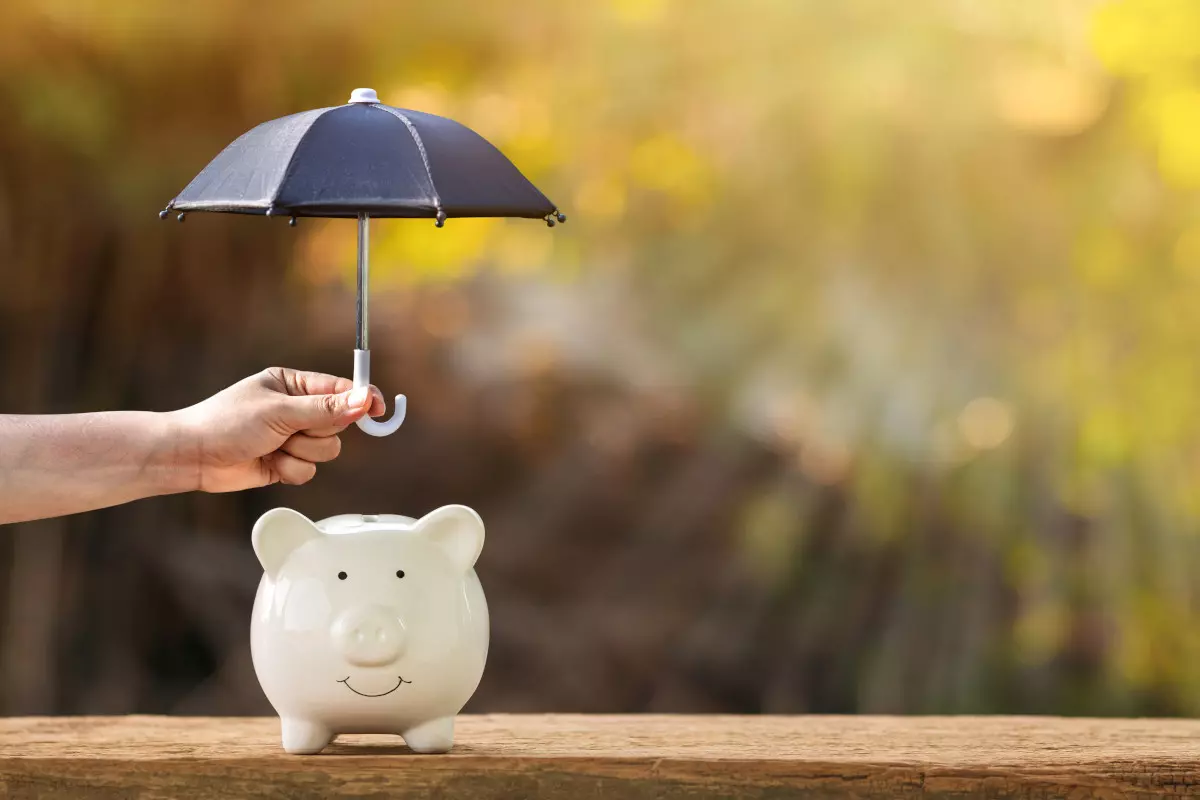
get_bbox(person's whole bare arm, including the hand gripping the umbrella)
[0,368,384,523]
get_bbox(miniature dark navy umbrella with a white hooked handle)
[160,89,566,437]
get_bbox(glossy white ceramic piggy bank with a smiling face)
[250,506,488,753]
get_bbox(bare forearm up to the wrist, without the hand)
[0,411,198,523]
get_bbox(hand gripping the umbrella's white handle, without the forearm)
[174,367,385,492]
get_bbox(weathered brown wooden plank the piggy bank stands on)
[0,715,1200,800]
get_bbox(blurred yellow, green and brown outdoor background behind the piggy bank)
[0,0,1200,715]
